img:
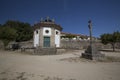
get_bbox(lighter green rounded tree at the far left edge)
[0,26,17,47]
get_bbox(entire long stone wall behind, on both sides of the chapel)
[19,40,114,49]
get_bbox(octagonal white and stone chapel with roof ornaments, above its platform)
[33,17,62,48]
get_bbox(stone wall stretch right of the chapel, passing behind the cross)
[61,40,112,49]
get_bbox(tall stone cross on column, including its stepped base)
[82,20,105,60]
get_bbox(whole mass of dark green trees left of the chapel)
[0,20,33,46]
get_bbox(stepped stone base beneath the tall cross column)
[82,46,105,60]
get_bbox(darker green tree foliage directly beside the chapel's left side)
[4,20,33,42]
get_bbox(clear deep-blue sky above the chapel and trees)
[0,0,120,37]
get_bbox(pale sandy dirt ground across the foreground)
[0,50,120,80]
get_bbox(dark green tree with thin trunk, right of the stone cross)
[100,31,120,51]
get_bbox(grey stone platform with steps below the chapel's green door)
[33,48,57,55]
